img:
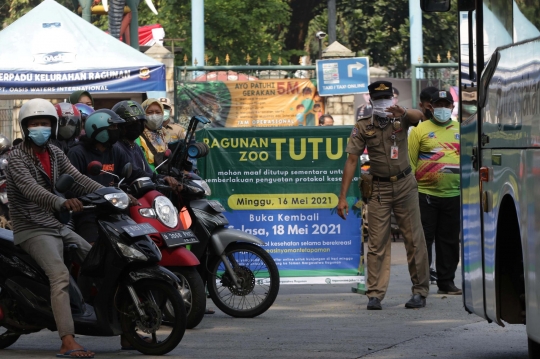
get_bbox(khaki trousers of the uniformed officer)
[367,174,429,300]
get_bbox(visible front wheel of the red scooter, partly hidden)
[167,267,206,329]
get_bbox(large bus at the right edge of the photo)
[420,0,540,358]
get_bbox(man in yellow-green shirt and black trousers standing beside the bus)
[409,91,461,295]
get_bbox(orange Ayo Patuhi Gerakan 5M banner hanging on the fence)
[175,78,324,127]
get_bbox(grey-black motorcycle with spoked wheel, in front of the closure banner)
[168,116,279,318]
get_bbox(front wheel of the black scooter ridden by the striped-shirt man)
[119,280,186,355]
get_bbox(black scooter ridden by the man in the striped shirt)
[0,170,186,355]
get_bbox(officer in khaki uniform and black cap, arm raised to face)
[338,81,429,310]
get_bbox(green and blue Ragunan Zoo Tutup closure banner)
[197,126,362,284]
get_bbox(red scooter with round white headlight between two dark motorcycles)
[87,161,206,329]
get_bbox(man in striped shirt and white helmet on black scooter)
[6,99,102,357]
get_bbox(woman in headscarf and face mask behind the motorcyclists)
[137,98,167,171]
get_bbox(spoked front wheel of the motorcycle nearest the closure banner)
[207,243,279,318]
